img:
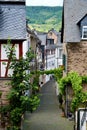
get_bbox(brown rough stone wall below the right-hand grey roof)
[67,41,87,75]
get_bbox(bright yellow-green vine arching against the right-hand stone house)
[59,72,87,112]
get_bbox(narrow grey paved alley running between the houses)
[23,80,74,130]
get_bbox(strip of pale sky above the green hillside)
[26,0,63,6]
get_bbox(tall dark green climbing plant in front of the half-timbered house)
[0,41,40,130]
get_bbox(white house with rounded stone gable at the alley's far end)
[45,29,62,79]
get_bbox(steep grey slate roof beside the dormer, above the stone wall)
[62,0,87,43]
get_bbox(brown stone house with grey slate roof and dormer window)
[61,0,87,115]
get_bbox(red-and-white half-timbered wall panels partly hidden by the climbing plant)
[0,44,22,78]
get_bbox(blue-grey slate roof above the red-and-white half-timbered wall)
[0,0,26,40]
